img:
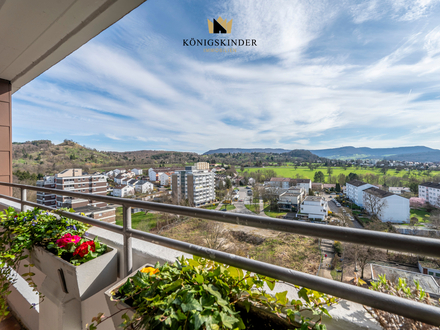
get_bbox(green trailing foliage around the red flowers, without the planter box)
[0,208,101,319]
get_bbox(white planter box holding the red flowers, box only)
[30,246,118,301]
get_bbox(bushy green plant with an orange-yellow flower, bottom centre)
[87,257,336,330]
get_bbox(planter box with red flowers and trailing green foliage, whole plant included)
[0,208,117,315]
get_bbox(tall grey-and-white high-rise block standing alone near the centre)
[171,164,215,206]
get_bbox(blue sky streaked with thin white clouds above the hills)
[13,0,440,153]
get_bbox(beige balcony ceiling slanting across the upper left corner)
[0,0,146,92]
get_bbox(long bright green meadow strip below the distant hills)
[239,166,432,181]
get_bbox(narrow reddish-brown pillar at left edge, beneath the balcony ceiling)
[0,79,12,196]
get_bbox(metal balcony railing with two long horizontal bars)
[0,182,440,326]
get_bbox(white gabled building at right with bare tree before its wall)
[362,187,410,223]
